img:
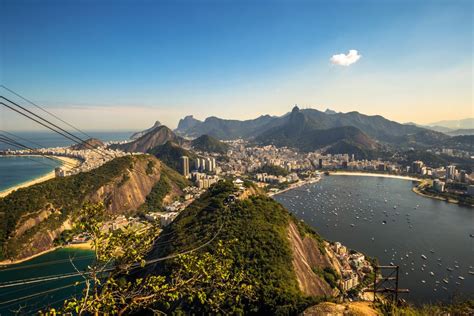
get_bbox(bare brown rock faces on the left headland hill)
[4,155,168,260]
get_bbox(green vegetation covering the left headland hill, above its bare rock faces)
[0,156,176,259]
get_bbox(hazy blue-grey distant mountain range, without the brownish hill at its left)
[175,106,462,158]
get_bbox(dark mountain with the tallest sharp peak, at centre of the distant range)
[255,106,380,159]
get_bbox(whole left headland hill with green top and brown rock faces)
[0,155,182,260]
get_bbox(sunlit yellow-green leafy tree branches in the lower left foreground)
[42,204,254,315]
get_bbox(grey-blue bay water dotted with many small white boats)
[275,176,474,303]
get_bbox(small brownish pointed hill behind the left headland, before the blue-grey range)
[110,125,187,153]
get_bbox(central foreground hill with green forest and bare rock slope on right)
[143,181,340,315]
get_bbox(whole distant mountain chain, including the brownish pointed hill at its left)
[125,106,472,159]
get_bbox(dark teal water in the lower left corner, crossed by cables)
[0,249,93,315]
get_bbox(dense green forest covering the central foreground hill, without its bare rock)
[147,182,314,314]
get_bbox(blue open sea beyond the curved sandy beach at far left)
[0,132,132,191]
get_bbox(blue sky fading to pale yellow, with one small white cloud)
[0,0,474,130]
